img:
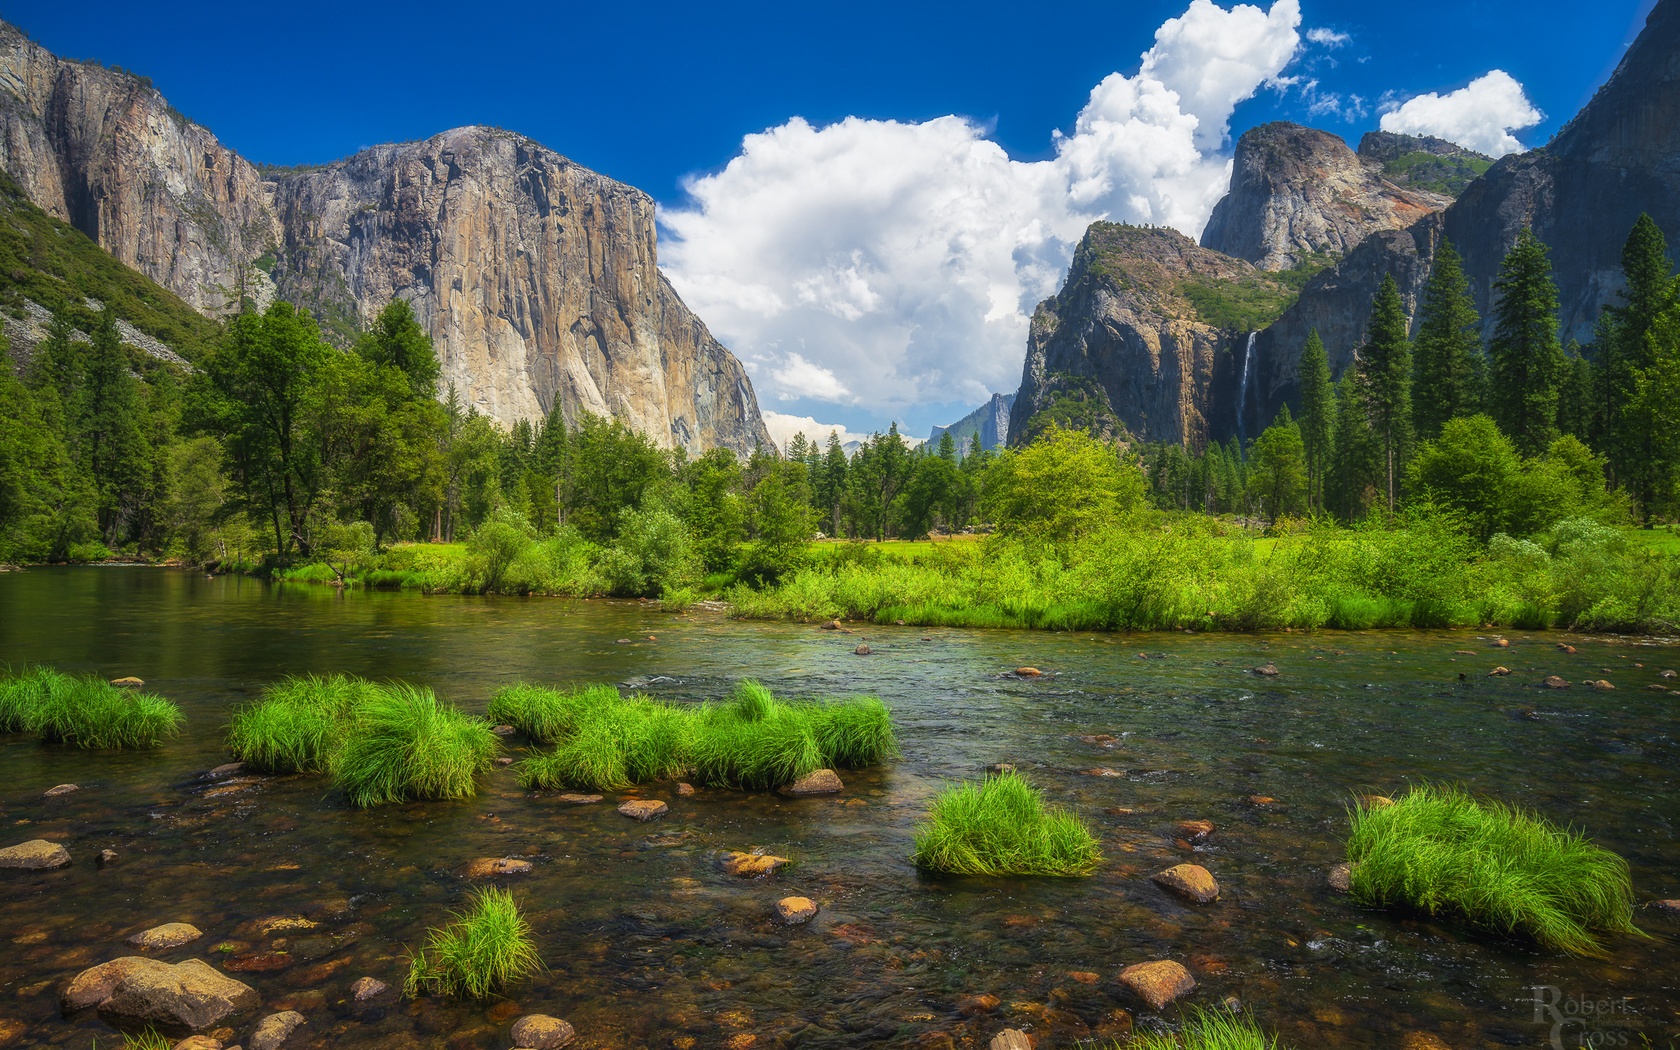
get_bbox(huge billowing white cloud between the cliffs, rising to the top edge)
[660,0,1300,426]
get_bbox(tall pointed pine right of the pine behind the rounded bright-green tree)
[1488,230,1564,457]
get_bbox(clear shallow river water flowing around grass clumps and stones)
[0,568,1680,1050]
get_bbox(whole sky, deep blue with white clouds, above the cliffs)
[0,0,1650,433]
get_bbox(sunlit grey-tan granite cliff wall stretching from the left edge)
[0,24,771,452]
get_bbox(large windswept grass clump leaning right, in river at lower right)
[1347,786,1638,954]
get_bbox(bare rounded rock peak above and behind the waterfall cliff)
[1201,121,1452,270]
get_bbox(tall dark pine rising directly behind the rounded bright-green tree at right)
[1411,240,1485,440]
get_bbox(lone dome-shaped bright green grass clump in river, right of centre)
[914,773,1102,875]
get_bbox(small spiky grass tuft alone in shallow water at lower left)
[403,889,543,1000]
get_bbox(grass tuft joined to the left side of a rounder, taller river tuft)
[227,674,381,773]
